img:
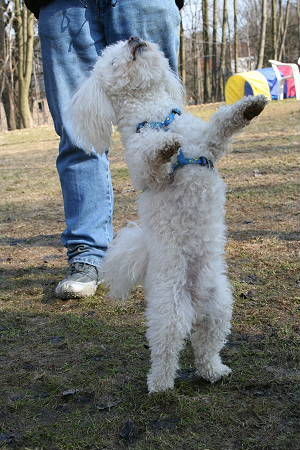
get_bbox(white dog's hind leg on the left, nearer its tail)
[146,256,194,392]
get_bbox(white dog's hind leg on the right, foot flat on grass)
[191,274,232,383]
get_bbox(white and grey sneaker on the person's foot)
[55,262,101,300]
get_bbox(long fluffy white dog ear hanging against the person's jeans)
[64,70,116,153]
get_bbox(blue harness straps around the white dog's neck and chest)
[136,108,214,172]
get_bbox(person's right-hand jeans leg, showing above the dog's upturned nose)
[104,0,180,72]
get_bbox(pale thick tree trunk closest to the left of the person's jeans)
[15,0,34,128]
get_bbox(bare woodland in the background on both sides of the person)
[0,0,300,124]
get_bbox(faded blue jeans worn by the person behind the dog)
[39,0,180,266]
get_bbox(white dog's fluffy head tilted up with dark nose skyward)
[66,37,183,152]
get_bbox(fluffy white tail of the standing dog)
[103,223,148,298]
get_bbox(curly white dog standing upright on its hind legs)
[69,38,267,392]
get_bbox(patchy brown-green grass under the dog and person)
[0,101,300,450]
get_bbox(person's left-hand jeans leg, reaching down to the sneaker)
[39,0,113,266]
